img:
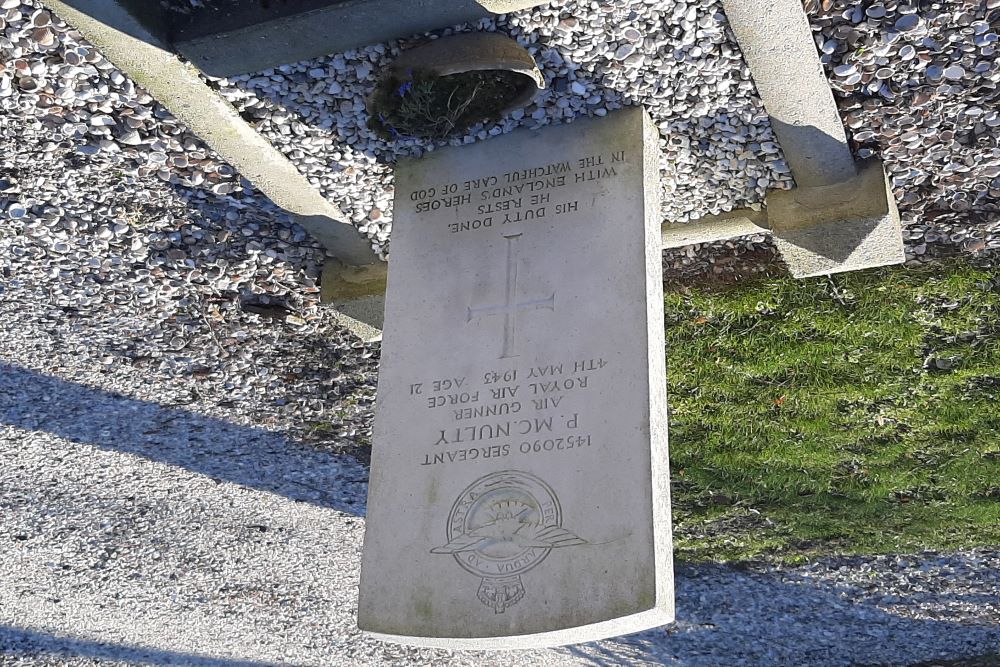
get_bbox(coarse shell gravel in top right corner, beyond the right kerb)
[807,0,1000,257]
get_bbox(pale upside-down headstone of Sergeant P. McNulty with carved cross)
[358,108,673,649]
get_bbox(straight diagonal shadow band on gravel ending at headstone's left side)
[0,361,368,516]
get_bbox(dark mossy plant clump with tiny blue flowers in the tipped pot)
[368,70,526,140]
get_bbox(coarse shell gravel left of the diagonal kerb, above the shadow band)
[0,0,377,448]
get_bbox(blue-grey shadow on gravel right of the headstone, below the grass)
[559,556,1000,667]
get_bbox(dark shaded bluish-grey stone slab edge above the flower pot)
[174,0,543,76]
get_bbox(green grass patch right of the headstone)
[666,260,1000,562]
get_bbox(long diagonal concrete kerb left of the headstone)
[45,0,385,336]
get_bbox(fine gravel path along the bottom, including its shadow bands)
[0,368,1000,666]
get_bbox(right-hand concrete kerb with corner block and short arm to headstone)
[663,0,905,278]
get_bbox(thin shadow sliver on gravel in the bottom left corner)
[0,625,277,667]
